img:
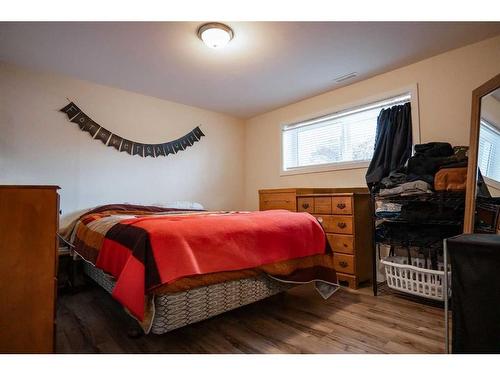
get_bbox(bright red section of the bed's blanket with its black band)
[96,210,326,321]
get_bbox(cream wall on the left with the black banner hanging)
[0,64,244,226]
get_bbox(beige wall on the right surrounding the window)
[245,33,500,209]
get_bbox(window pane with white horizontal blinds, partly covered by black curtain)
[282,94,411,172]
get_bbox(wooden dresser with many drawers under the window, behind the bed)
[259,188,373,289]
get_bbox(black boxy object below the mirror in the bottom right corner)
[447,234,500,353]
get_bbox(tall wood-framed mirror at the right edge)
[464,74,500,234]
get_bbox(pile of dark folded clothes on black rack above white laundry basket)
[375,142,468,269]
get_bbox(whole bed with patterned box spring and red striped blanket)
[63,204,339,334]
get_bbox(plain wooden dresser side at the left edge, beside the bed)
[0,186,59,353]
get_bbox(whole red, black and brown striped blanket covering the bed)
[65,205,337,323]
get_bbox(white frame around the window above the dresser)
[279,83,420,176]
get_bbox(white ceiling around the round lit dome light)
[0,22,500,118]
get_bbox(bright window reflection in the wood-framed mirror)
[478,119,500,181]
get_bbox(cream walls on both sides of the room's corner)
[0,37,500,222]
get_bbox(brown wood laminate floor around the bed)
[56,285,444,353]
